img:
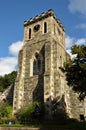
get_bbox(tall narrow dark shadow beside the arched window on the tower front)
[33,45,45,103]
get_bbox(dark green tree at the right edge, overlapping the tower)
[62,45,86,100]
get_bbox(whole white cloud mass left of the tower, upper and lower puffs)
[0,41,23,75]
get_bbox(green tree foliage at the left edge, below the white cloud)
[0,71,17,91]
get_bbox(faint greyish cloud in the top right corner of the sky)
[68,0,86,15]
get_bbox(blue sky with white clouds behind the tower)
[0,0,86,75]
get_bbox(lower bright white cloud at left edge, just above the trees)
[0,57,17,75]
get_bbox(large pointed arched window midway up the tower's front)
[33,52,42,75]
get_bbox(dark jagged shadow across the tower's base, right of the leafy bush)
[45,95,68,122]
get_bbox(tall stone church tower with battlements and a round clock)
[13,10,84,118]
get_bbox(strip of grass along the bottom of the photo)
[0,121,86,130]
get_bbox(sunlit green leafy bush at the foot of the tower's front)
[16,102,44,123]
